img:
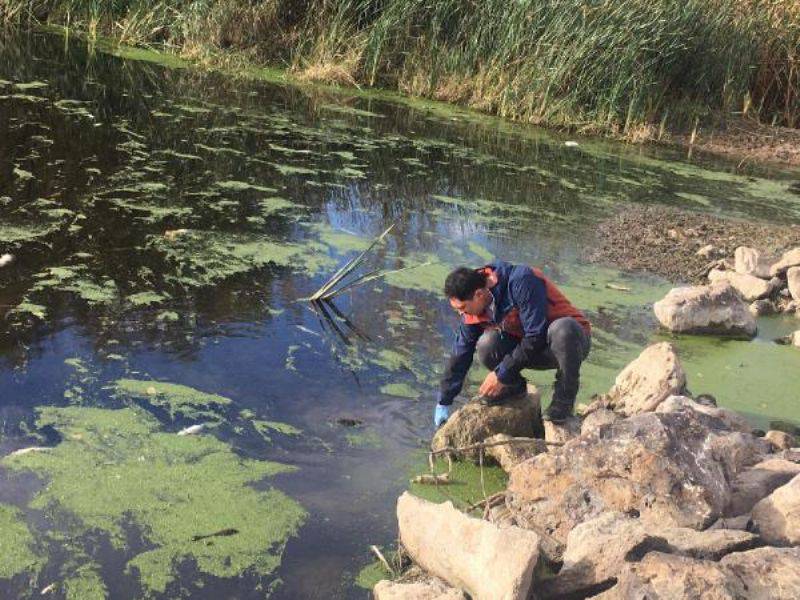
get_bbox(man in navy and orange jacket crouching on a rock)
[434,261,591,427]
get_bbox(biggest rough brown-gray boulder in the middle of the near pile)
[506,410,757,556]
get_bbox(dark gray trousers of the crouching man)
[476,317,592,406]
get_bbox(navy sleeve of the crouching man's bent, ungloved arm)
[495,269,547,384]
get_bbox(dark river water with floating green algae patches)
[0,32,800,599]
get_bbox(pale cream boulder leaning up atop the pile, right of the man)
[600,342,686,416]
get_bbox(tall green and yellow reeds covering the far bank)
[0,0,800,140]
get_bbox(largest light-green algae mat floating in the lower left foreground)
[0,407,306,594]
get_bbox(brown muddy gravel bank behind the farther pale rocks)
[588,206,800,283]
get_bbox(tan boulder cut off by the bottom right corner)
[720,548,800,600]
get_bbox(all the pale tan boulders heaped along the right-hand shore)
[373,247,800,600]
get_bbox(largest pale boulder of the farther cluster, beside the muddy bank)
[653,281,757,338]
